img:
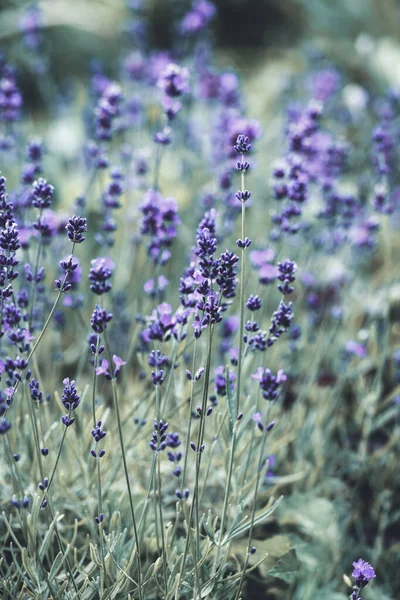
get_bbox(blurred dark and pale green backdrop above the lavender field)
[0,0,400,105]
